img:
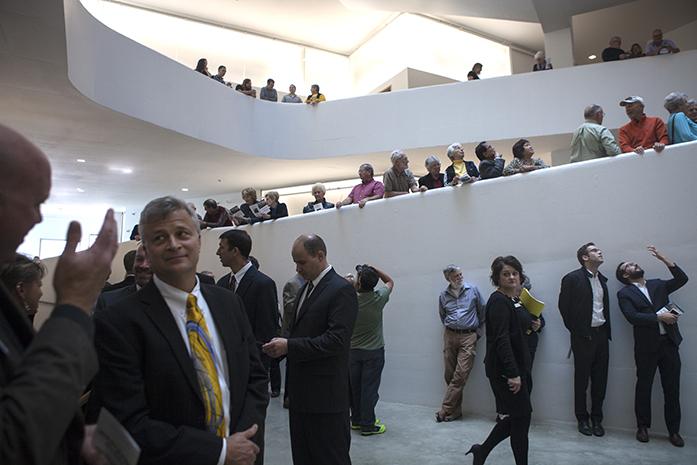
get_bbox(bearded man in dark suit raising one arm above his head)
[616,245,687,447]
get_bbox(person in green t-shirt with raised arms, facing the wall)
[350,265,394,436]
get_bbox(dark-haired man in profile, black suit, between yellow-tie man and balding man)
[216,229,281,397]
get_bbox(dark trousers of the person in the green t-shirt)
[350,347,385,430]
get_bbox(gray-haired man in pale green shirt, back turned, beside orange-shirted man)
[569,104,622,163]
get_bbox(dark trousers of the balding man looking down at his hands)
[288,410,351,465]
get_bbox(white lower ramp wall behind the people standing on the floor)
[39,142,697,436]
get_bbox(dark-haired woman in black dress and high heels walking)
[467,255,532,465]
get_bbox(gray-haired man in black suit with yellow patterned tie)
[95,197,268,465]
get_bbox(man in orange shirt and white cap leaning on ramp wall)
[620,95,668,155]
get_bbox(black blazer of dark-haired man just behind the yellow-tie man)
[218,266,280,344]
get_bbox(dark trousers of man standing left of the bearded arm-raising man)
[571,325,610,422]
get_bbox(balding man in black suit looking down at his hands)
[263,235,358,465]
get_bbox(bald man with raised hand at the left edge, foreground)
[0,125,117,465]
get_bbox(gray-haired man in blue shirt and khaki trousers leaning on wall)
[436,265,486,423]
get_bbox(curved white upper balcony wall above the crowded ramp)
[65,0,697,159]
